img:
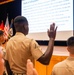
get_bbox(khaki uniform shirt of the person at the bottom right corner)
[51,57,74,75]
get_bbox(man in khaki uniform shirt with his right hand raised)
[5,16,57,75]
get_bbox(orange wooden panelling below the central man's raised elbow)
[35,55,67,75]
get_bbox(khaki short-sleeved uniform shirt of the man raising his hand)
[5,32,43,73]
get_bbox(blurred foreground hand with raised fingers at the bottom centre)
[27,59,38,75]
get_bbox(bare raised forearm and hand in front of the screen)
[37,23,57,65]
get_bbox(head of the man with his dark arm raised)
[14,16,28,33]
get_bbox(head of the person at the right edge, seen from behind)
[67,36,74,54]
